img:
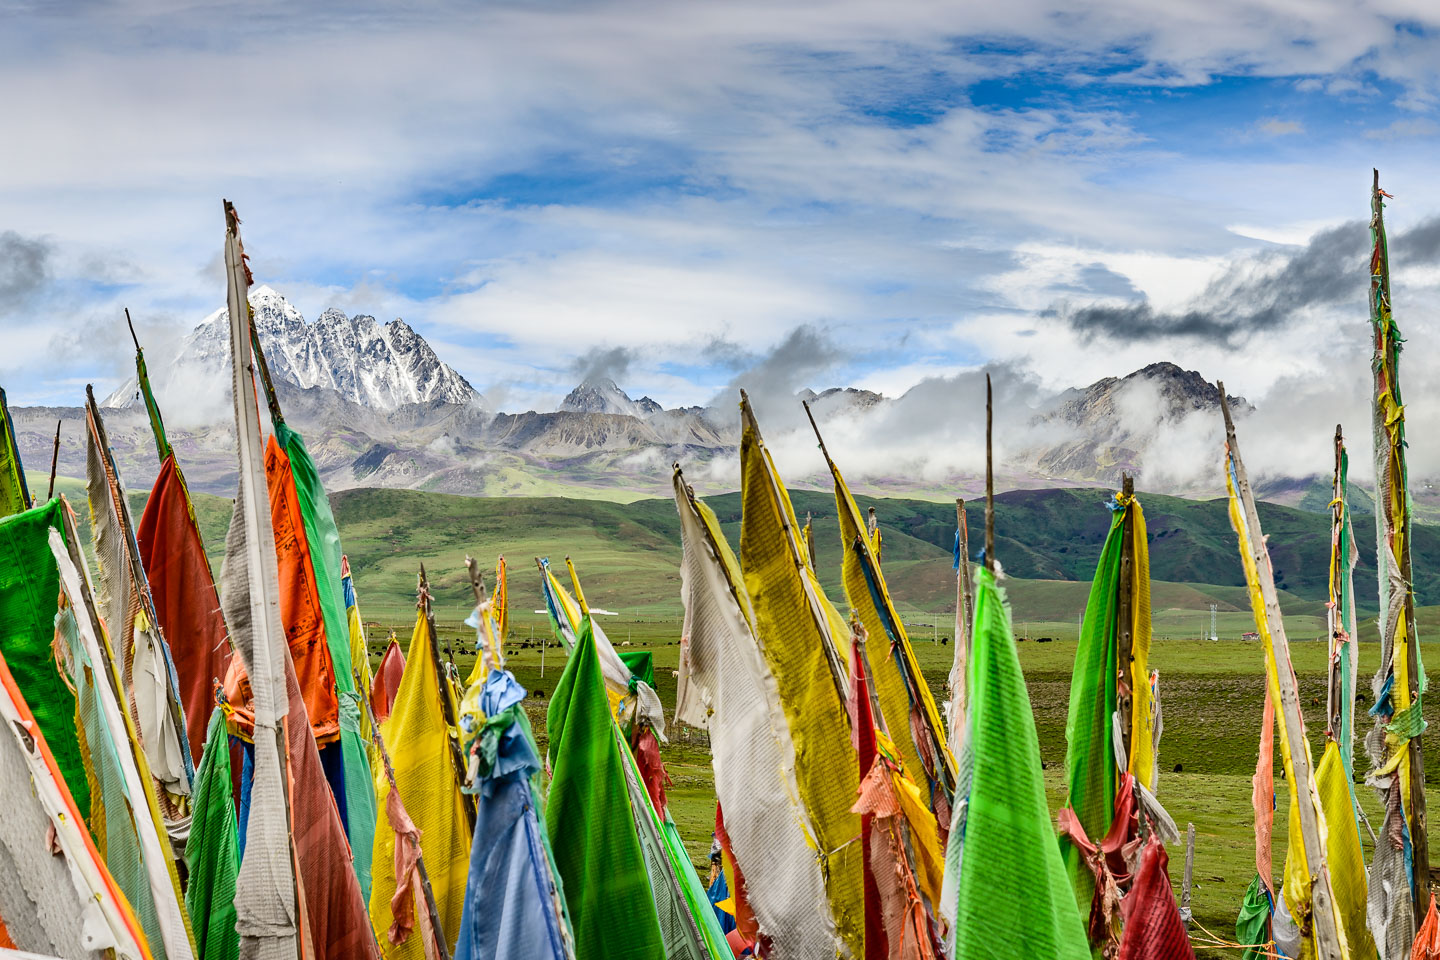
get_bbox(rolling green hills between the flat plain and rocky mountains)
[312,480,1416,622]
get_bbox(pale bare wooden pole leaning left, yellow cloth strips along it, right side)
[1215,383,1342,960]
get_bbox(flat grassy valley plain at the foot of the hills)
[362,627,1440,957]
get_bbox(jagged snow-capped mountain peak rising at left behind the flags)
[105,285,480,412]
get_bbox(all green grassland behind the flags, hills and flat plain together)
[75,485,1440,957]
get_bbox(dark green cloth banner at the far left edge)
[0,498,89,818]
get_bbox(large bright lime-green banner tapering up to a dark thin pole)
[955,569,1090,960]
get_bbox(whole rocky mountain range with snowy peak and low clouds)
[12,286,1328,502]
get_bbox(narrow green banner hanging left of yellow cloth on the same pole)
[1060,510,1125,914]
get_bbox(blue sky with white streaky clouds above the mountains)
[0,0,1440,443]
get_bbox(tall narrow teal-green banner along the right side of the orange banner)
[275,422,377,902]
